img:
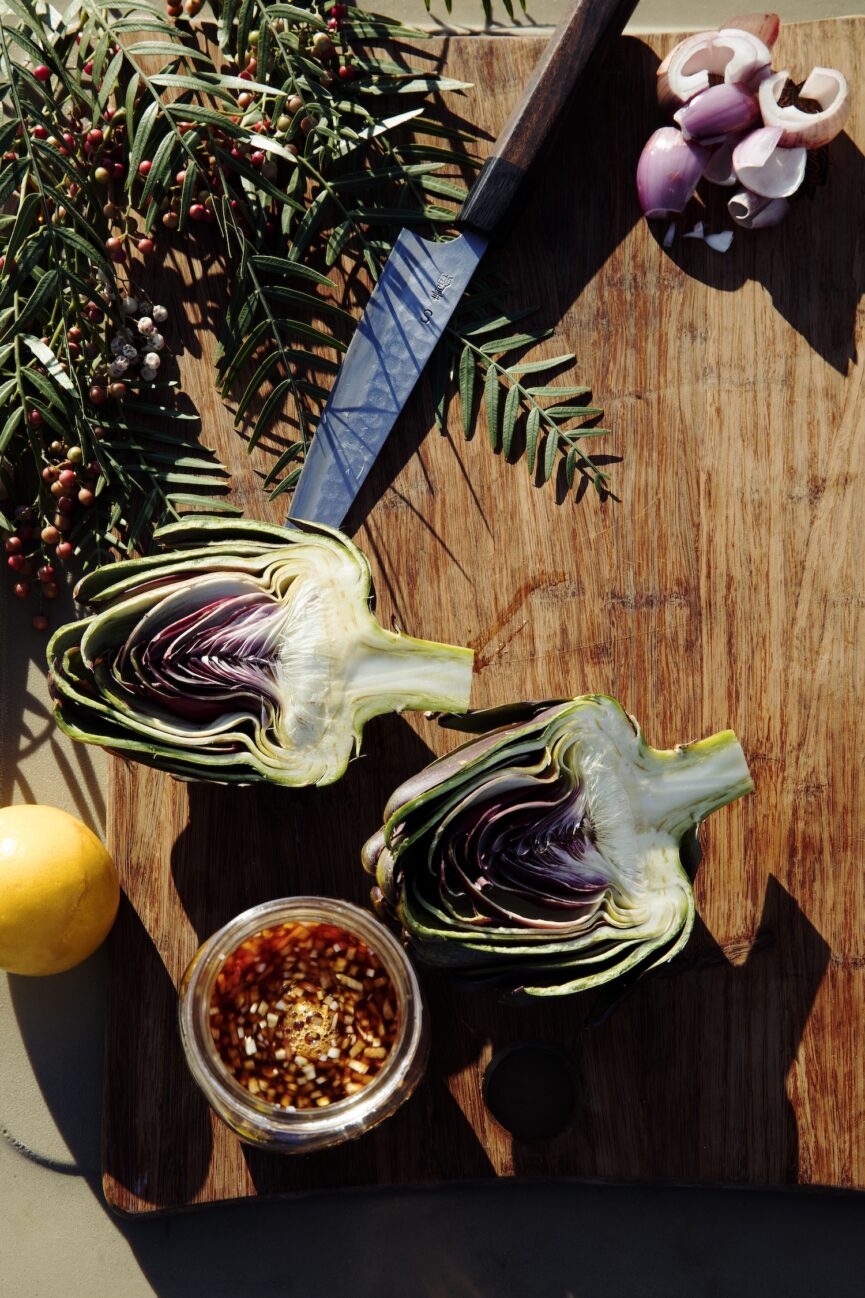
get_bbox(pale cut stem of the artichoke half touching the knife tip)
[347,624,474,726]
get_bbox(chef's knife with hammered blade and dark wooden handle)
[288,0,636,527]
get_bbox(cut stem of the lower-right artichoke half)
[634,731,753,835]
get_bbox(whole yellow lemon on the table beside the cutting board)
[0,806,119,974]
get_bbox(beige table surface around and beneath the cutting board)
[0,0,865,1298]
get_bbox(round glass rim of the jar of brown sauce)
[178,896,423,1136]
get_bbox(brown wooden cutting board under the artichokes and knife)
[104,19,865,1214]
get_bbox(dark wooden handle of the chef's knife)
[457,0,636,239]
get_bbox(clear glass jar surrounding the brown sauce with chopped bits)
[179,897,429,1154]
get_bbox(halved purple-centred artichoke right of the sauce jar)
[362,694,753,996]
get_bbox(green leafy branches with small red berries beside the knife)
[0,0,607,625]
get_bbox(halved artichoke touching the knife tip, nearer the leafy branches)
[48,519,473,785]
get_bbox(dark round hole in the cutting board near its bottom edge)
[483,1041,577,1140]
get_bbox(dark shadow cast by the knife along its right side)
[344,36,649,533]
